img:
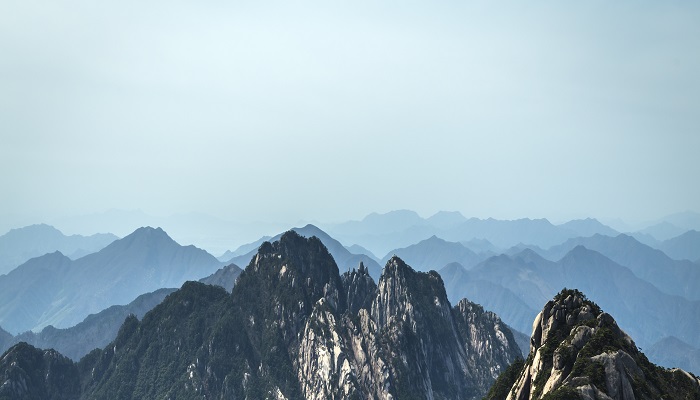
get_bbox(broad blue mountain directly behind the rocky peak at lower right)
[440,246,700,360]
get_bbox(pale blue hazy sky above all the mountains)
[0,0,700,231]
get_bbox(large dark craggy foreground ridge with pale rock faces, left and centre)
[0,232,520,399]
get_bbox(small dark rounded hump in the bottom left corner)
[0,343,80,400]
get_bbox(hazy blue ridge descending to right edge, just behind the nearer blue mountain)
[536,234,700,300]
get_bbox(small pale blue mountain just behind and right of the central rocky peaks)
[383,236,482,271]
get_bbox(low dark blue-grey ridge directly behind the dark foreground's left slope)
[0,289,175,361]
